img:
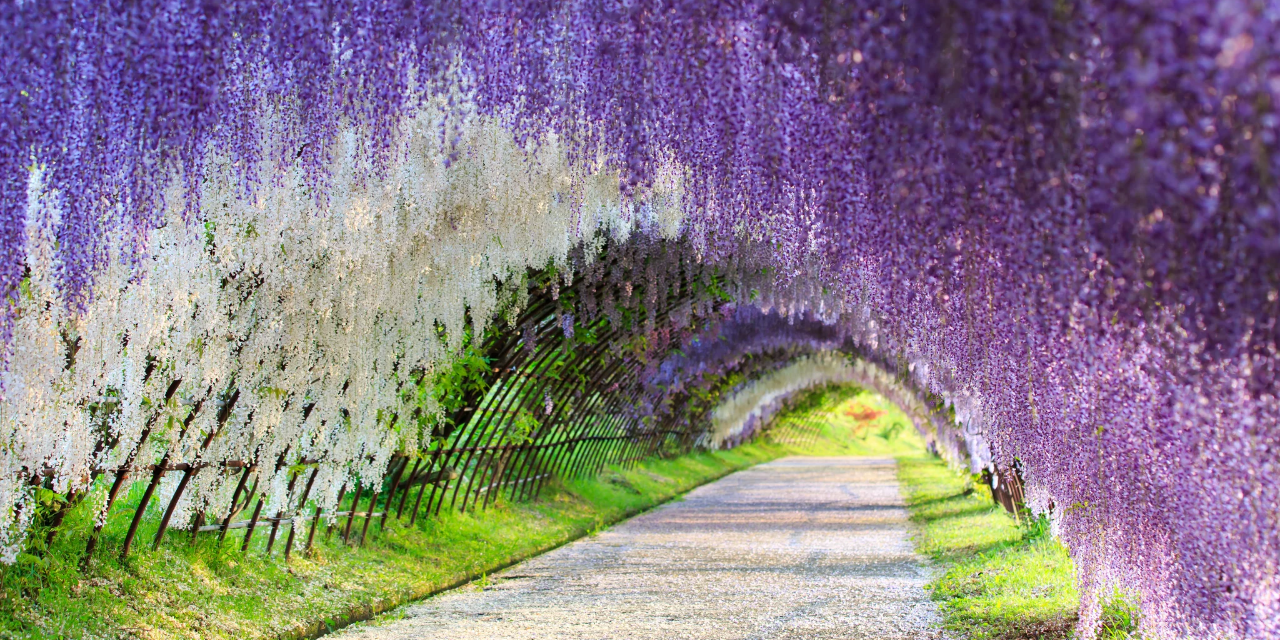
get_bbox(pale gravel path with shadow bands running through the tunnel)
[337,458,945,640]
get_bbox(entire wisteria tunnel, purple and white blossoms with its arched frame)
[0,0,1280,639]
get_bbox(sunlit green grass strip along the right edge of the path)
[897,453,1137,640]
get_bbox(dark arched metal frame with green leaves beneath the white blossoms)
[32,239,860,559]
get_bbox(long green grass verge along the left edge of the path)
[0,430,841,639]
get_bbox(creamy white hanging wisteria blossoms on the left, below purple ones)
[0,102,678,553]
